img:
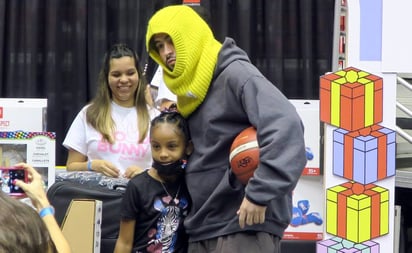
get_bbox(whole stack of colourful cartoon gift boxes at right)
[317,67,396,253]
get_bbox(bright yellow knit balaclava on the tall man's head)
[146,5,222,117]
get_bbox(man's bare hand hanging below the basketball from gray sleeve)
[237,198,266,228]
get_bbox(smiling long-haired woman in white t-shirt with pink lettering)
[63,44,158,178]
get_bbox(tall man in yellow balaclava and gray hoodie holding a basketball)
[146,5,306,253]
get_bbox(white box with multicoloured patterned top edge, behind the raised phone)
[0,131,56,188]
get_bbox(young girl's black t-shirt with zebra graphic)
[121,171,190,253]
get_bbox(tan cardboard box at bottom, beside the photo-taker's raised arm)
[62,199,103,253]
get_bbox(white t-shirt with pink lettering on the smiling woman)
[63,102,159,174]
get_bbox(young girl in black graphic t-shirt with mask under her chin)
[114,112,193,253]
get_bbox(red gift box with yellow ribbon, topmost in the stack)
[320,67,383,131]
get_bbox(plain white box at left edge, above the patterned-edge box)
[0,98,47,132]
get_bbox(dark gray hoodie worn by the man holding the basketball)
[185,38,306,241]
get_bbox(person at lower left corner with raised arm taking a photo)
[0,163,71,253]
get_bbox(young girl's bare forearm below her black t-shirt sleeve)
[114,219,136,253]
